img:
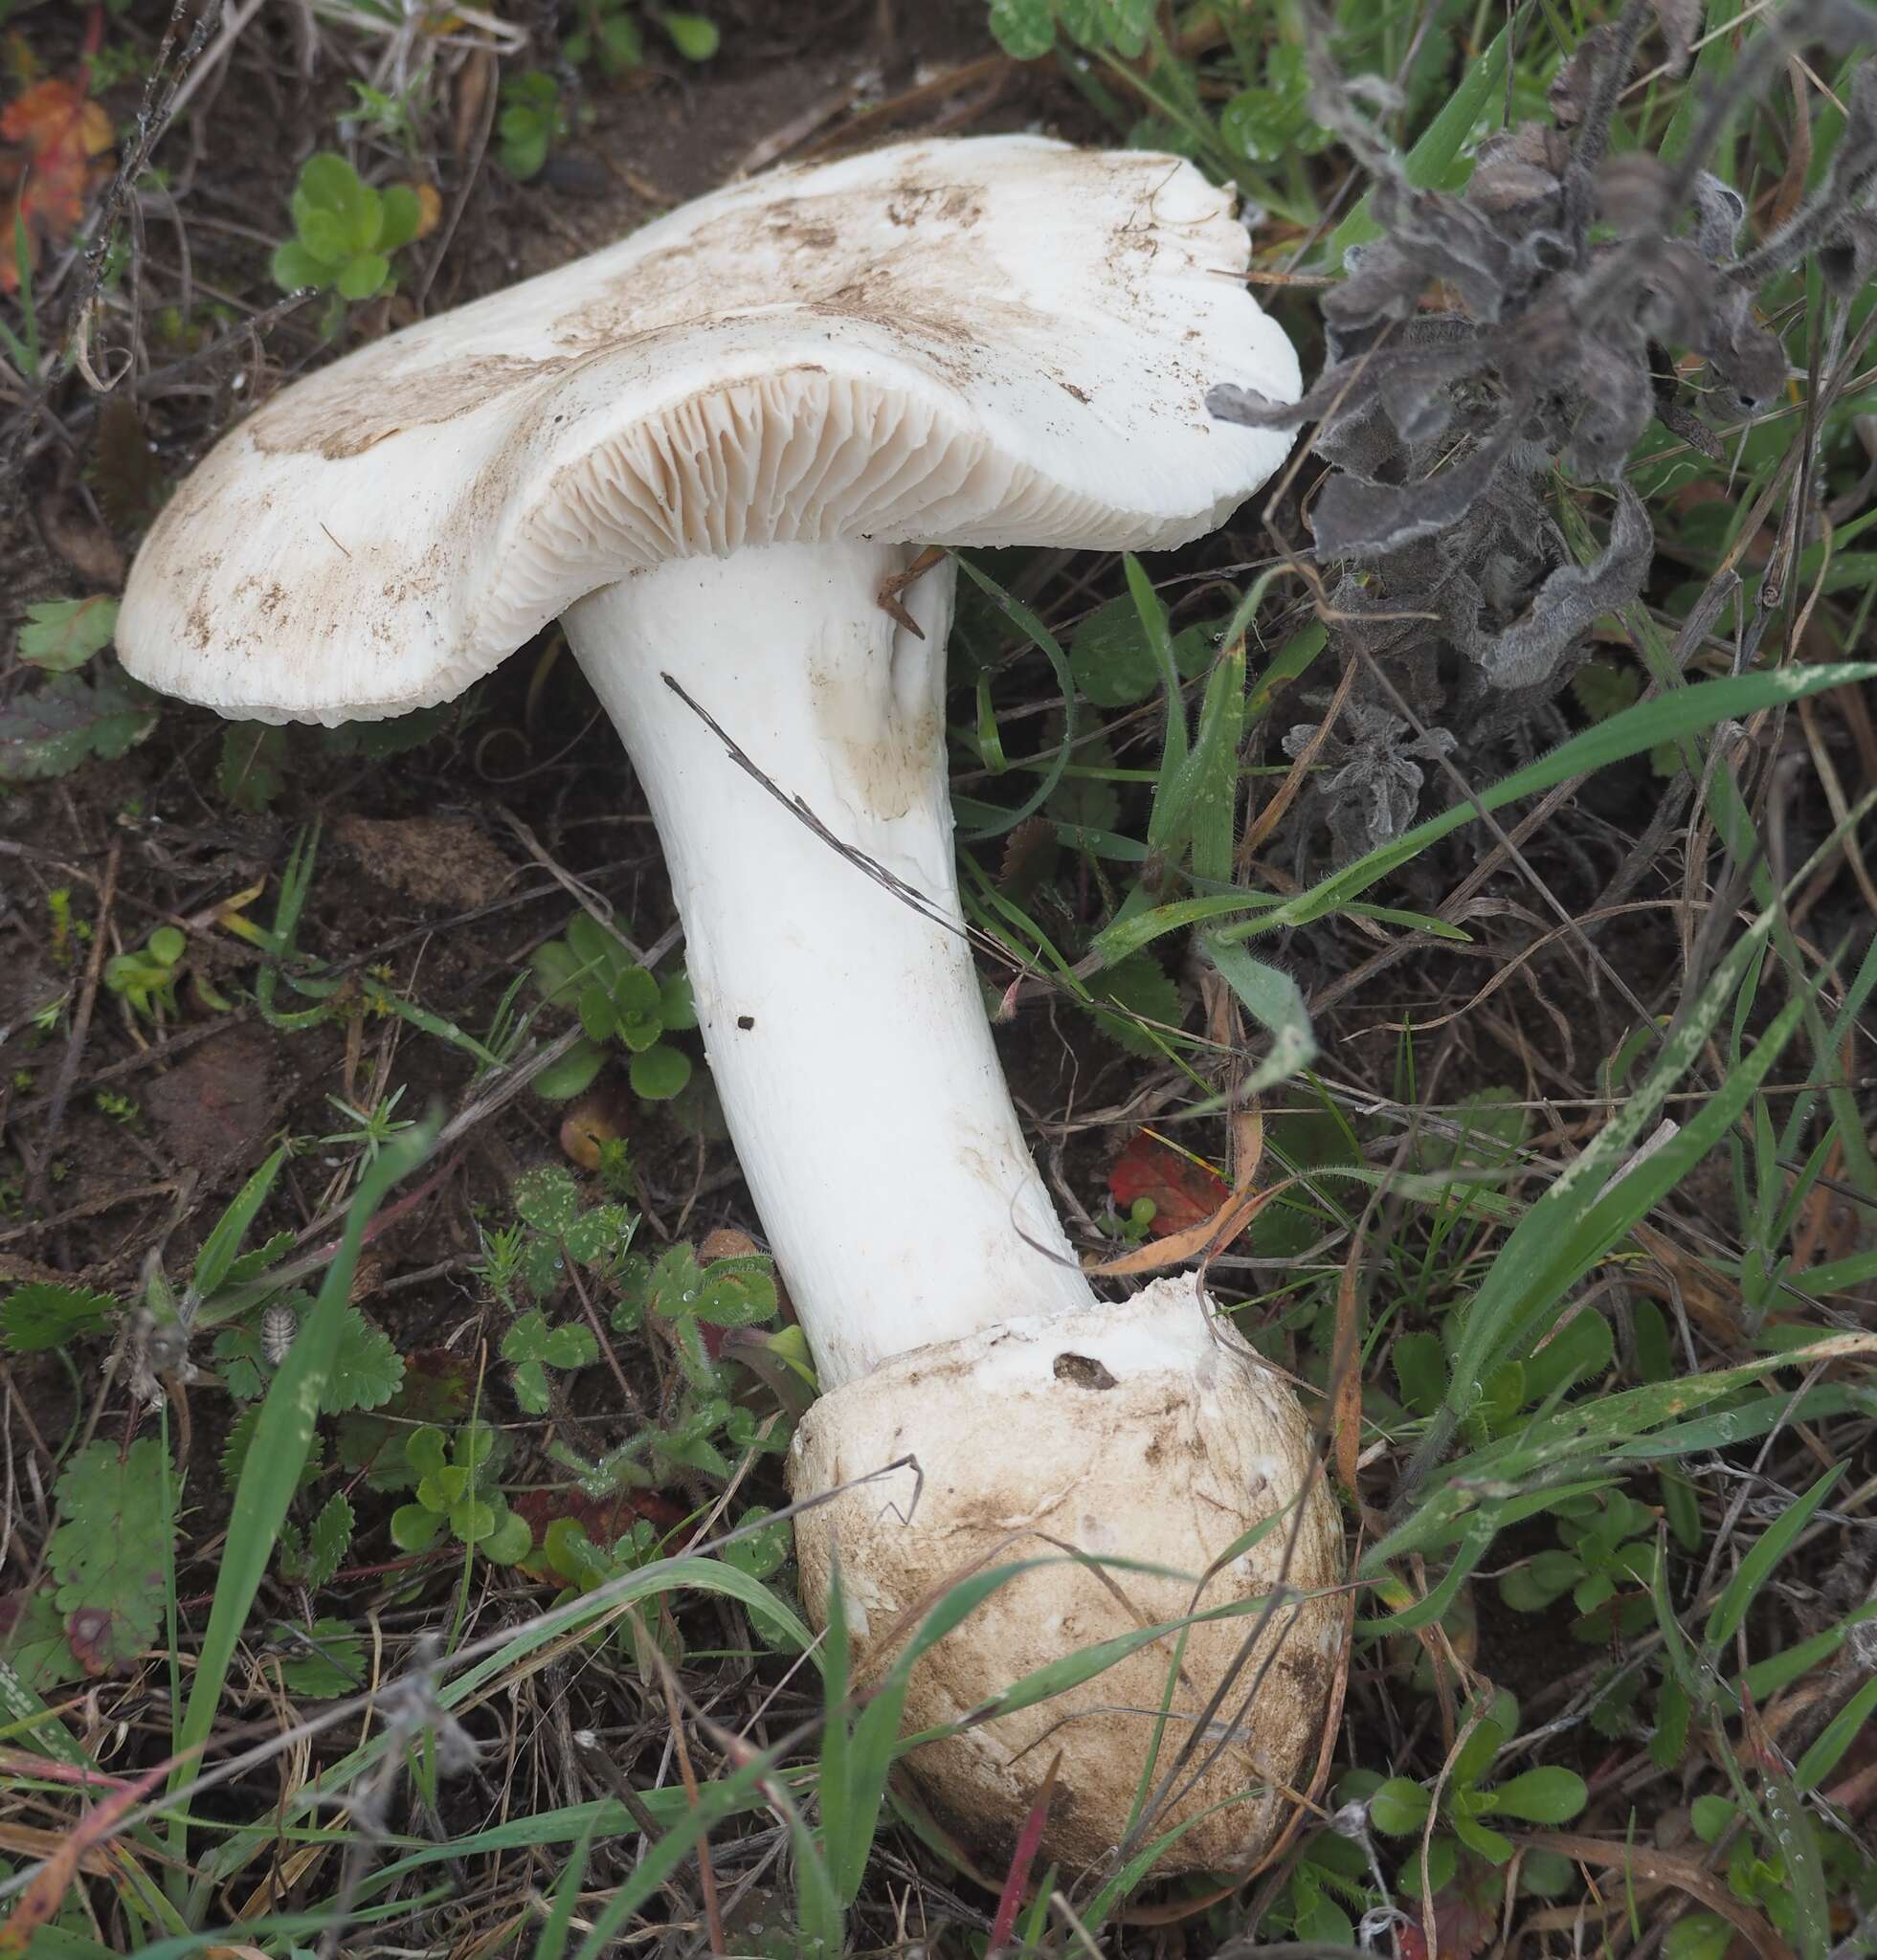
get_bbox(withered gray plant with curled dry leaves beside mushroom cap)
[1207,0,1877,860]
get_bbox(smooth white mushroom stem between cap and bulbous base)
[562,539,1093,1390]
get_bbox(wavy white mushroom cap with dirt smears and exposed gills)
[118,137,1299,722]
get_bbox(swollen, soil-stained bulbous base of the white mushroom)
[790,1280,1344,1870]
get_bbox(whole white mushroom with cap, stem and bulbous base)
[118,137,1340,1864]
